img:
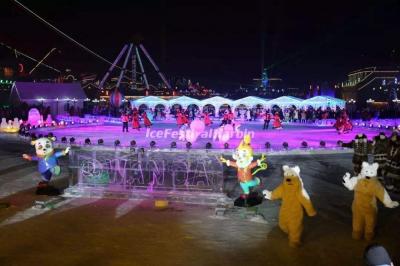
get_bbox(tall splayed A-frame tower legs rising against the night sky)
[99,43,171,90]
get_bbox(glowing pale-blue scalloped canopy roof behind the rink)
[131,96,346,114]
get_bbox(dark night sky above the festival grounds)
[0,0,400,89]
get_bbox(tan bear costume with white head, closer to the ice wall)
[263,165,317,247]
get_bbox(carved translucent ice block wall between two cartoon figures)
[64,147,231,206]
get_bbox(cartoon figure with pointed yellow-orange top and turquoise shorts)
[220,135,267,206]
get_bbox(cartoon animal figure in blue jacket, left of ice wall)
[22,138,70,195]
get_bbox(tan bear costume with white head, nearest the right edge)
[343,162,399,241]
